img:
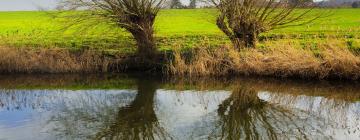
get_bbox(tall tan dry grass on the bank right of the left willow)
[165,39,360,79]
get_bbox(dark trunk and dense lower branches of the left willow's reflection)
[96,79,168,140]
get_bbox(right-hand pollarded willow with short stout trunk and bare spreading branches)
[210,0,321,50]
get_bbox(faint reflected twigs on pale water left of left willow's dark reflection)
[48,90,135,139]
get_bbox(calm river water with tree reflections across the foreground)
[0,75,360,140]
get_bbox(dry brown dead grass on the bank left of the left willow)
[0,47,128,73]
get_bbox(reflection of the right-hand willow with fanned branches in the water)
[209,86,330,139]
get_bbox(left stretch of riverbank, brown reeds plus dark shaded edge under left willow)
[0,47,161,73]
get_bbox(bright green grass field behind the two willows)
[0,9,360,52]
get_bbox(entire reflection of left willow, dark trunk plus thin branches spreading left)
[44,78,169,139]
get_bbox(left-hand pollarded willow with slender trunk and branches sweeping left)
[59,0,164,56]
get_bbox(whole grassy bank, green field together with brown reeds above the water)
[0,9,360,79]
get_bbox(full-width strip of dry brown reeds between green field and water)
[0,39,360,80]
